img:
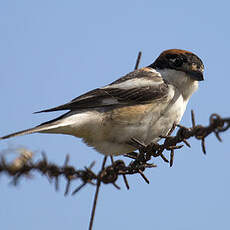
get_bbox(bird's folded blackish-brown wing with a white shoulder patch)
[36,68,168,113]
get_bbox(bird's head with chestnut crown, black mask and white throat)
[149,49,204,99]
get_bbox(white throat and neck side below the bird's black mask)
[157,69,198,100]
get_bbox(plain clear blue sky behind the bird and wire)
[0,0,230,230]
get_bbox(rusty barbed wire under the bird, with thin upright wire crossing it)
[0,52,230,230]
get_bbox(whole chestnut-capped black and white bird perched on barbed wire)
[0,49,204,156]
